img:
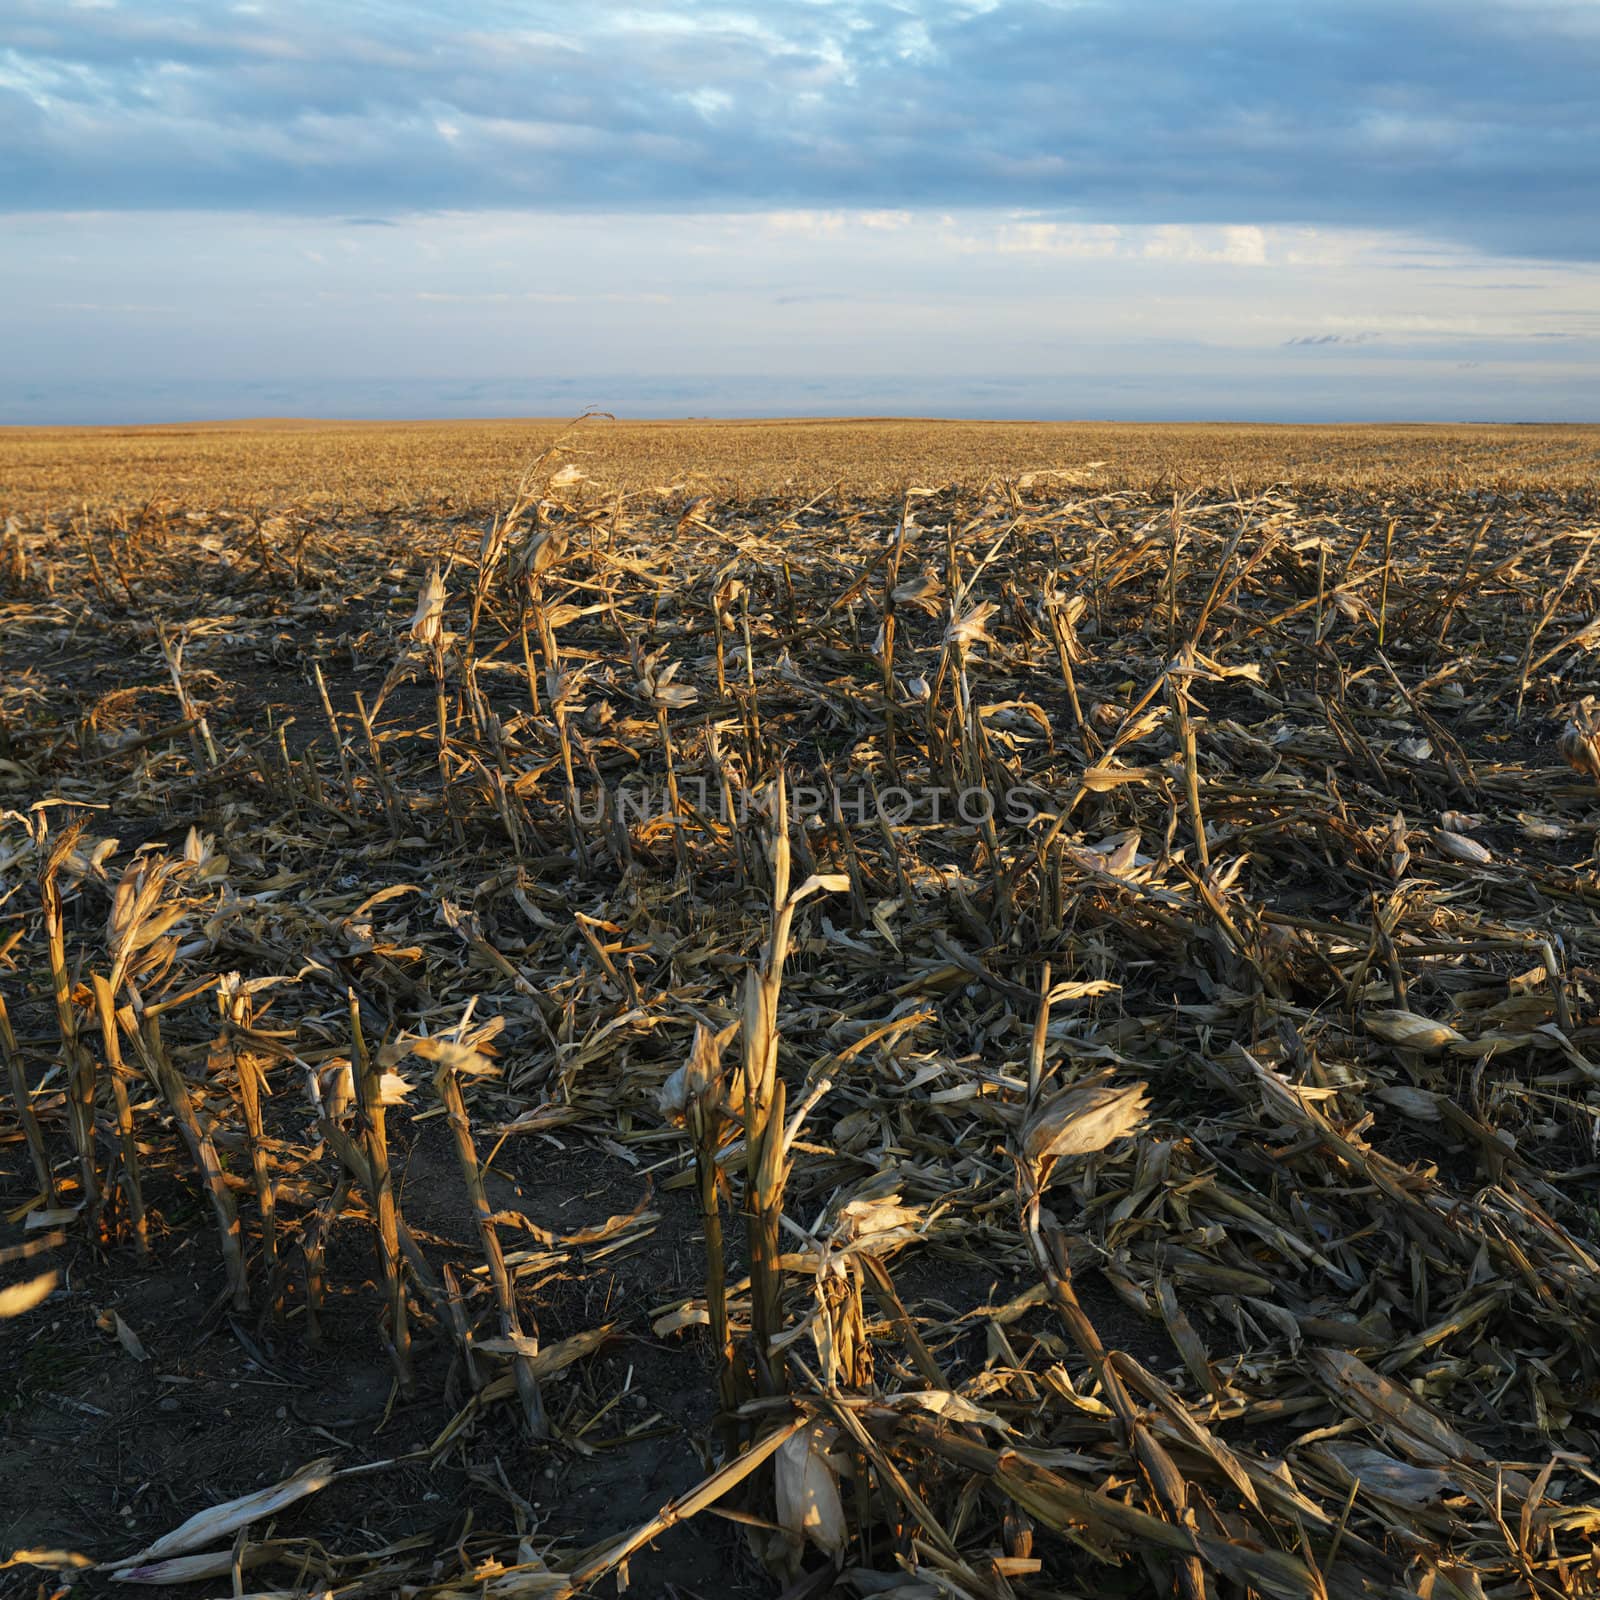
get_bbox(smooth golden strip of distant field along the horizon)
[0,418,1600,515]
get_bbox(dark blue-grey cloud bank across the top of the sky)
[0,0,1600,259]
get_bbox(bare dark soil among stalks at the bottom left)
[0,1122,773,1597]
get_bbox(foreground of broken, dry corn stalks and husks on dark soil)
[0,425,1600,1600]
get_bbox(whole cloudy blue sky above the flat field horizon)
[0,0,1600,422]
